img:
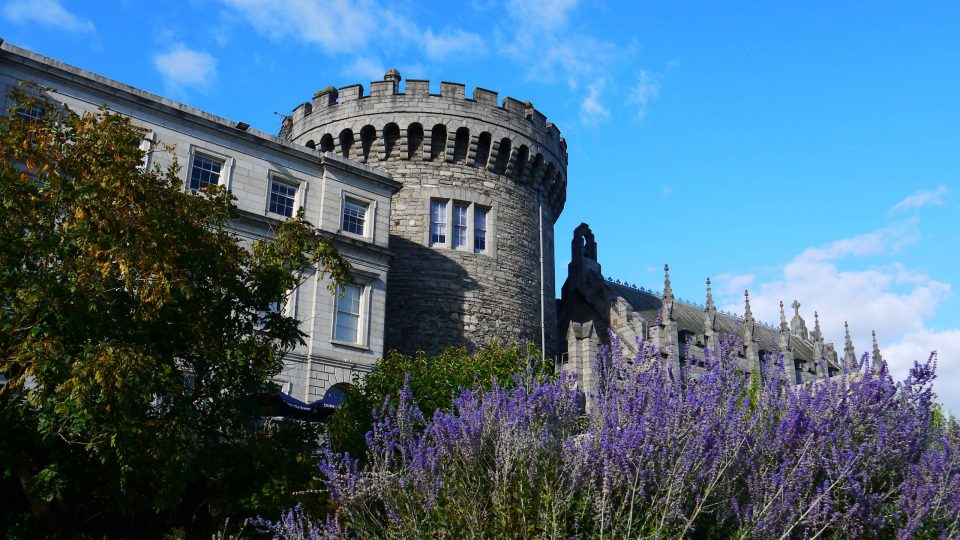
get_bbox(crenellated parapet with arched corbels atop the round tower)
[285,70,567,220]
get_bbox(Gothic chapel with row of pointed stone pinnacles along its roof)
[557,223,880,391]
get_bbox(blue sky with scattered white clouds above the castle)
[0,0,960,413]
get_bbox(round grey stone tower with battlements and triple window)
[282,69,567,355]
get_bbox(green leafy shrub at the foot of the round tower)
[328,344,552,462]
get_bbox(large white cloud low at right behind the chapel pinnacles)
[715,220,960,413]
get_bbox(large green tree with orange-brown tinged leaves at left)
[0,88,350,537]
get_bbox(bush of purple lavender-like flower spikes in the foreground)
[258,341,960,538]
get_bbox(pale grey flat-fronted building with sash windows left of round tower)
[0,43,400,401]
